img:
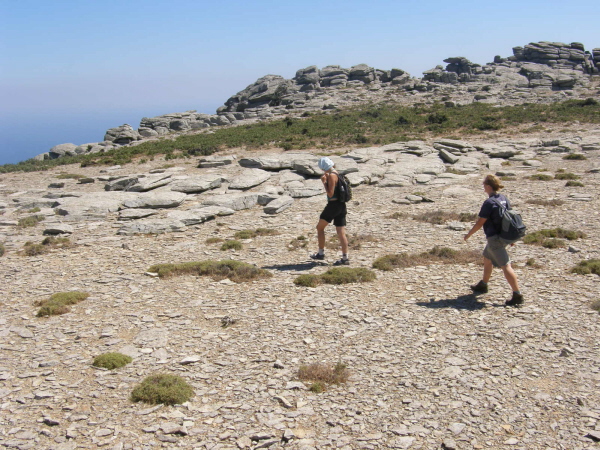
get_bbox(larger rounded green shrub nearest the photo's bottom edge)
[131,374,194,405]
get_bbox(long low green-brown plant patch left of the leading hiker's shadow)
[148,259,273,283]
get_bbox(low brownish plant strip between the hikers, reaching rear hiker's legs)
[373,245,481,271]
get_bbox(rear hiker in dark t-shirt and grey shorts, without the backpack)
[464,175,523,307]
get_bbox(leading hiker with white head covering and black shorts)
[310,156,350,266]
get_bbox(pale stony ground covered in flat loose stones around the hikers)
[0,126,600,450]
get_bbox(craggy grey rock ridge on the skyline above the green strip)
[35,42,600,160]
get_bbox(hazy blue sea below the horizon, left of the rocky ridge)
[0,105,217,165]
